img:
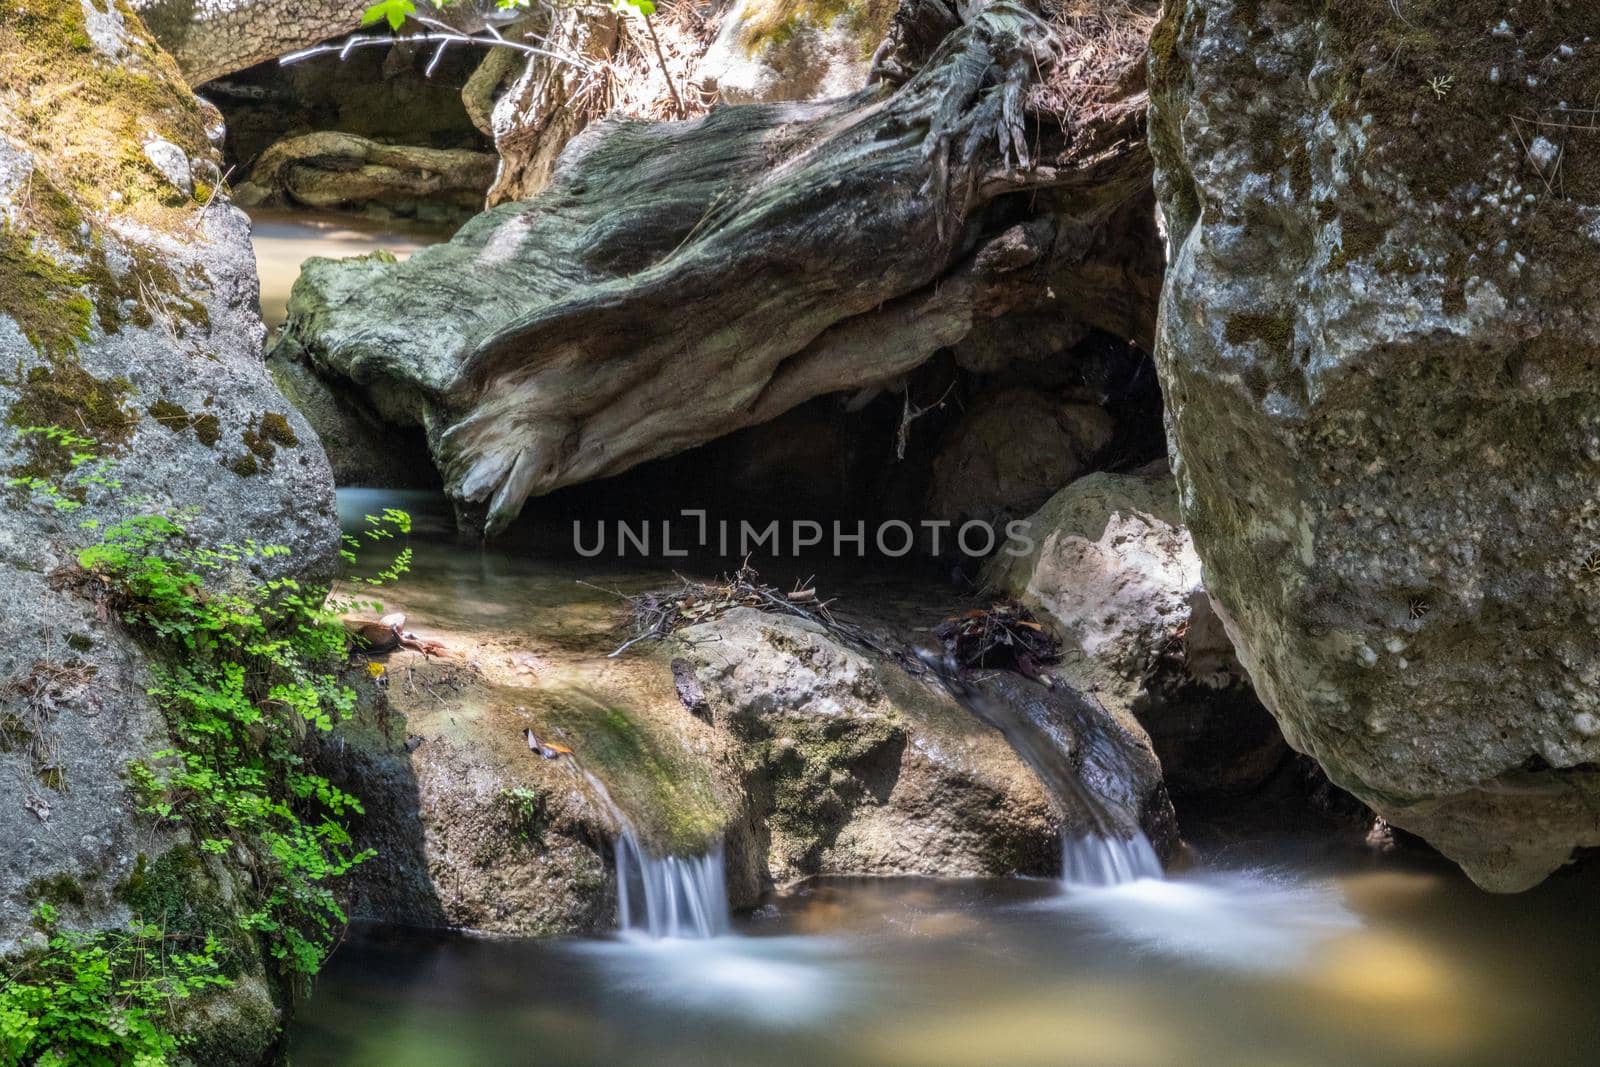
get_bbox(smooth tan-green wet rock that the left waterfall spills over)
[318,659,748,936]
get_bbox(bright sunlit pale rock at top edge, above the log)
[698,0,894,104]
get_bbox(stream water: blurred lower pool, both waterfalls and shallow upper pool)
[259,220,1600,1067]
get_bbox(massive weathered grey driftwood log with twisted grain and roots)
[274,0,1160,533]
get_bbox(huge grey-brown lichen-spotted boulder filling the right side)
[1150,0,1600,891]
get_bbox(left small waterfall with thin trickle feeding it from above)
[582,771,731,941]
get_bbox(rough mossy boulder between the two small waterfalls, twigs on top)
[680,608,1174,883]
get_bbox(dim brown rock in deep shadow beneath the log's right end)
[928,387,1114,523]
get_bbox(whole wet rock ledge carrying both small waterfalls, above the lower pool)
[318,534,1176,936]
